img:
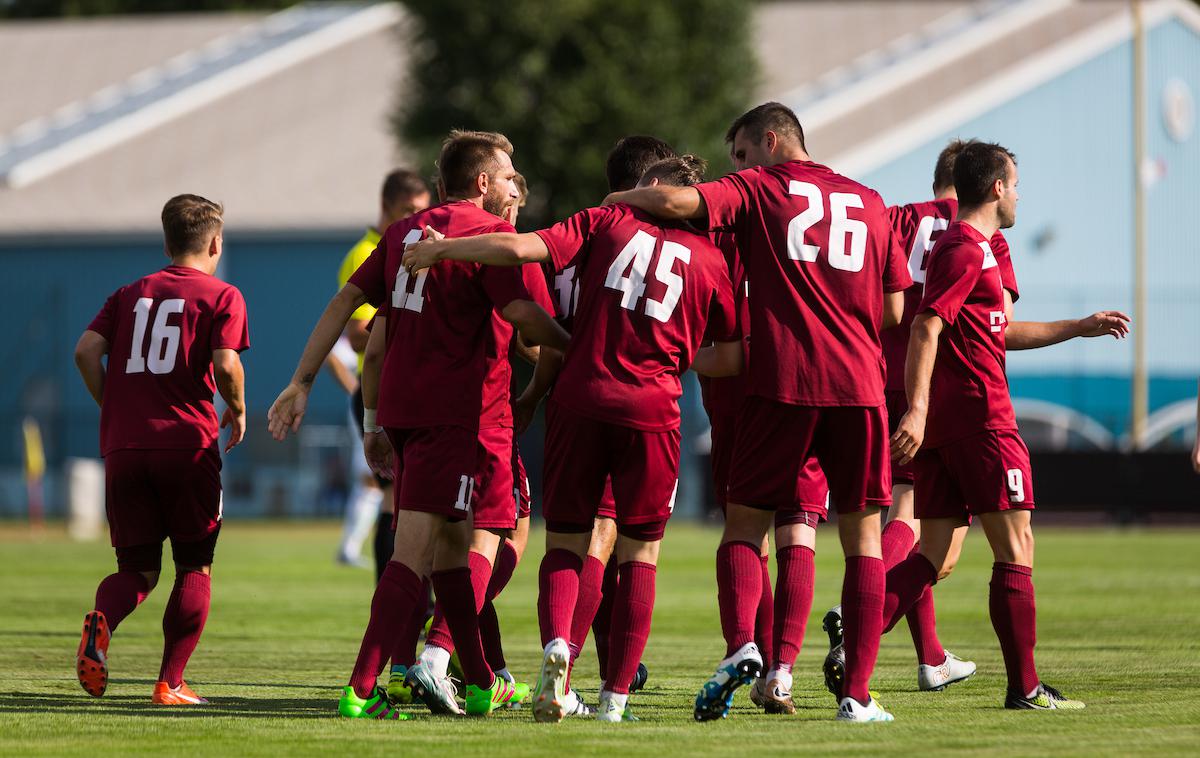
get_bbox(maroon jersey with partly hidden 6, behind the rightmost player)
[881,198,1021,392]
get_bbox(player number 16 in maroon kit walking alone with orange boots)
[76,194,250,705]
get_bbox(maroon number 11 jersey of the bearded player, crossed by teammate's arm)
[350,200,530,431]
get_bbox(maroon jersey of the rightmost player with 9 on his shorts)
[920,222,1016,447]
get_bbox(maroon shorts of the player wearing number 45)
[541,401,679,531]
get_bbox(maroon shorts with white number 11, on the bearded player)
[385,426,479,528]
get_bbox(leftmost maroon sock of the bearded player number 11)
[349,560,425,698]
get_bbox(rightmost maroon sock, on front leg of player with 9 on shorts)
[988,563,1039,696]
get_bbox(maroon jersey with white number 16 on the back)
[88,266,250,456]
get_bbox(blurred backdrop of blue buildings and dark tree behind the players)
[0,0,1200,532]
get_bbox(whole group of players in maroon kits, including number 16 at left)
[76,103,1128,722]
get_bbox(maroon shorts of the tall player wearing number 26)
[728,396,892,515]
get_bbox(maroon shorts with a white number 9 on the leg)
[913,429,1033,521]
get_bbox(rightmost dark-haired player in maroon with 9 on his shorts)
[884,143,1128,709]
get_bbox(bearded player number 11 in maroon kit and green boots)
[268,131,566,720]
